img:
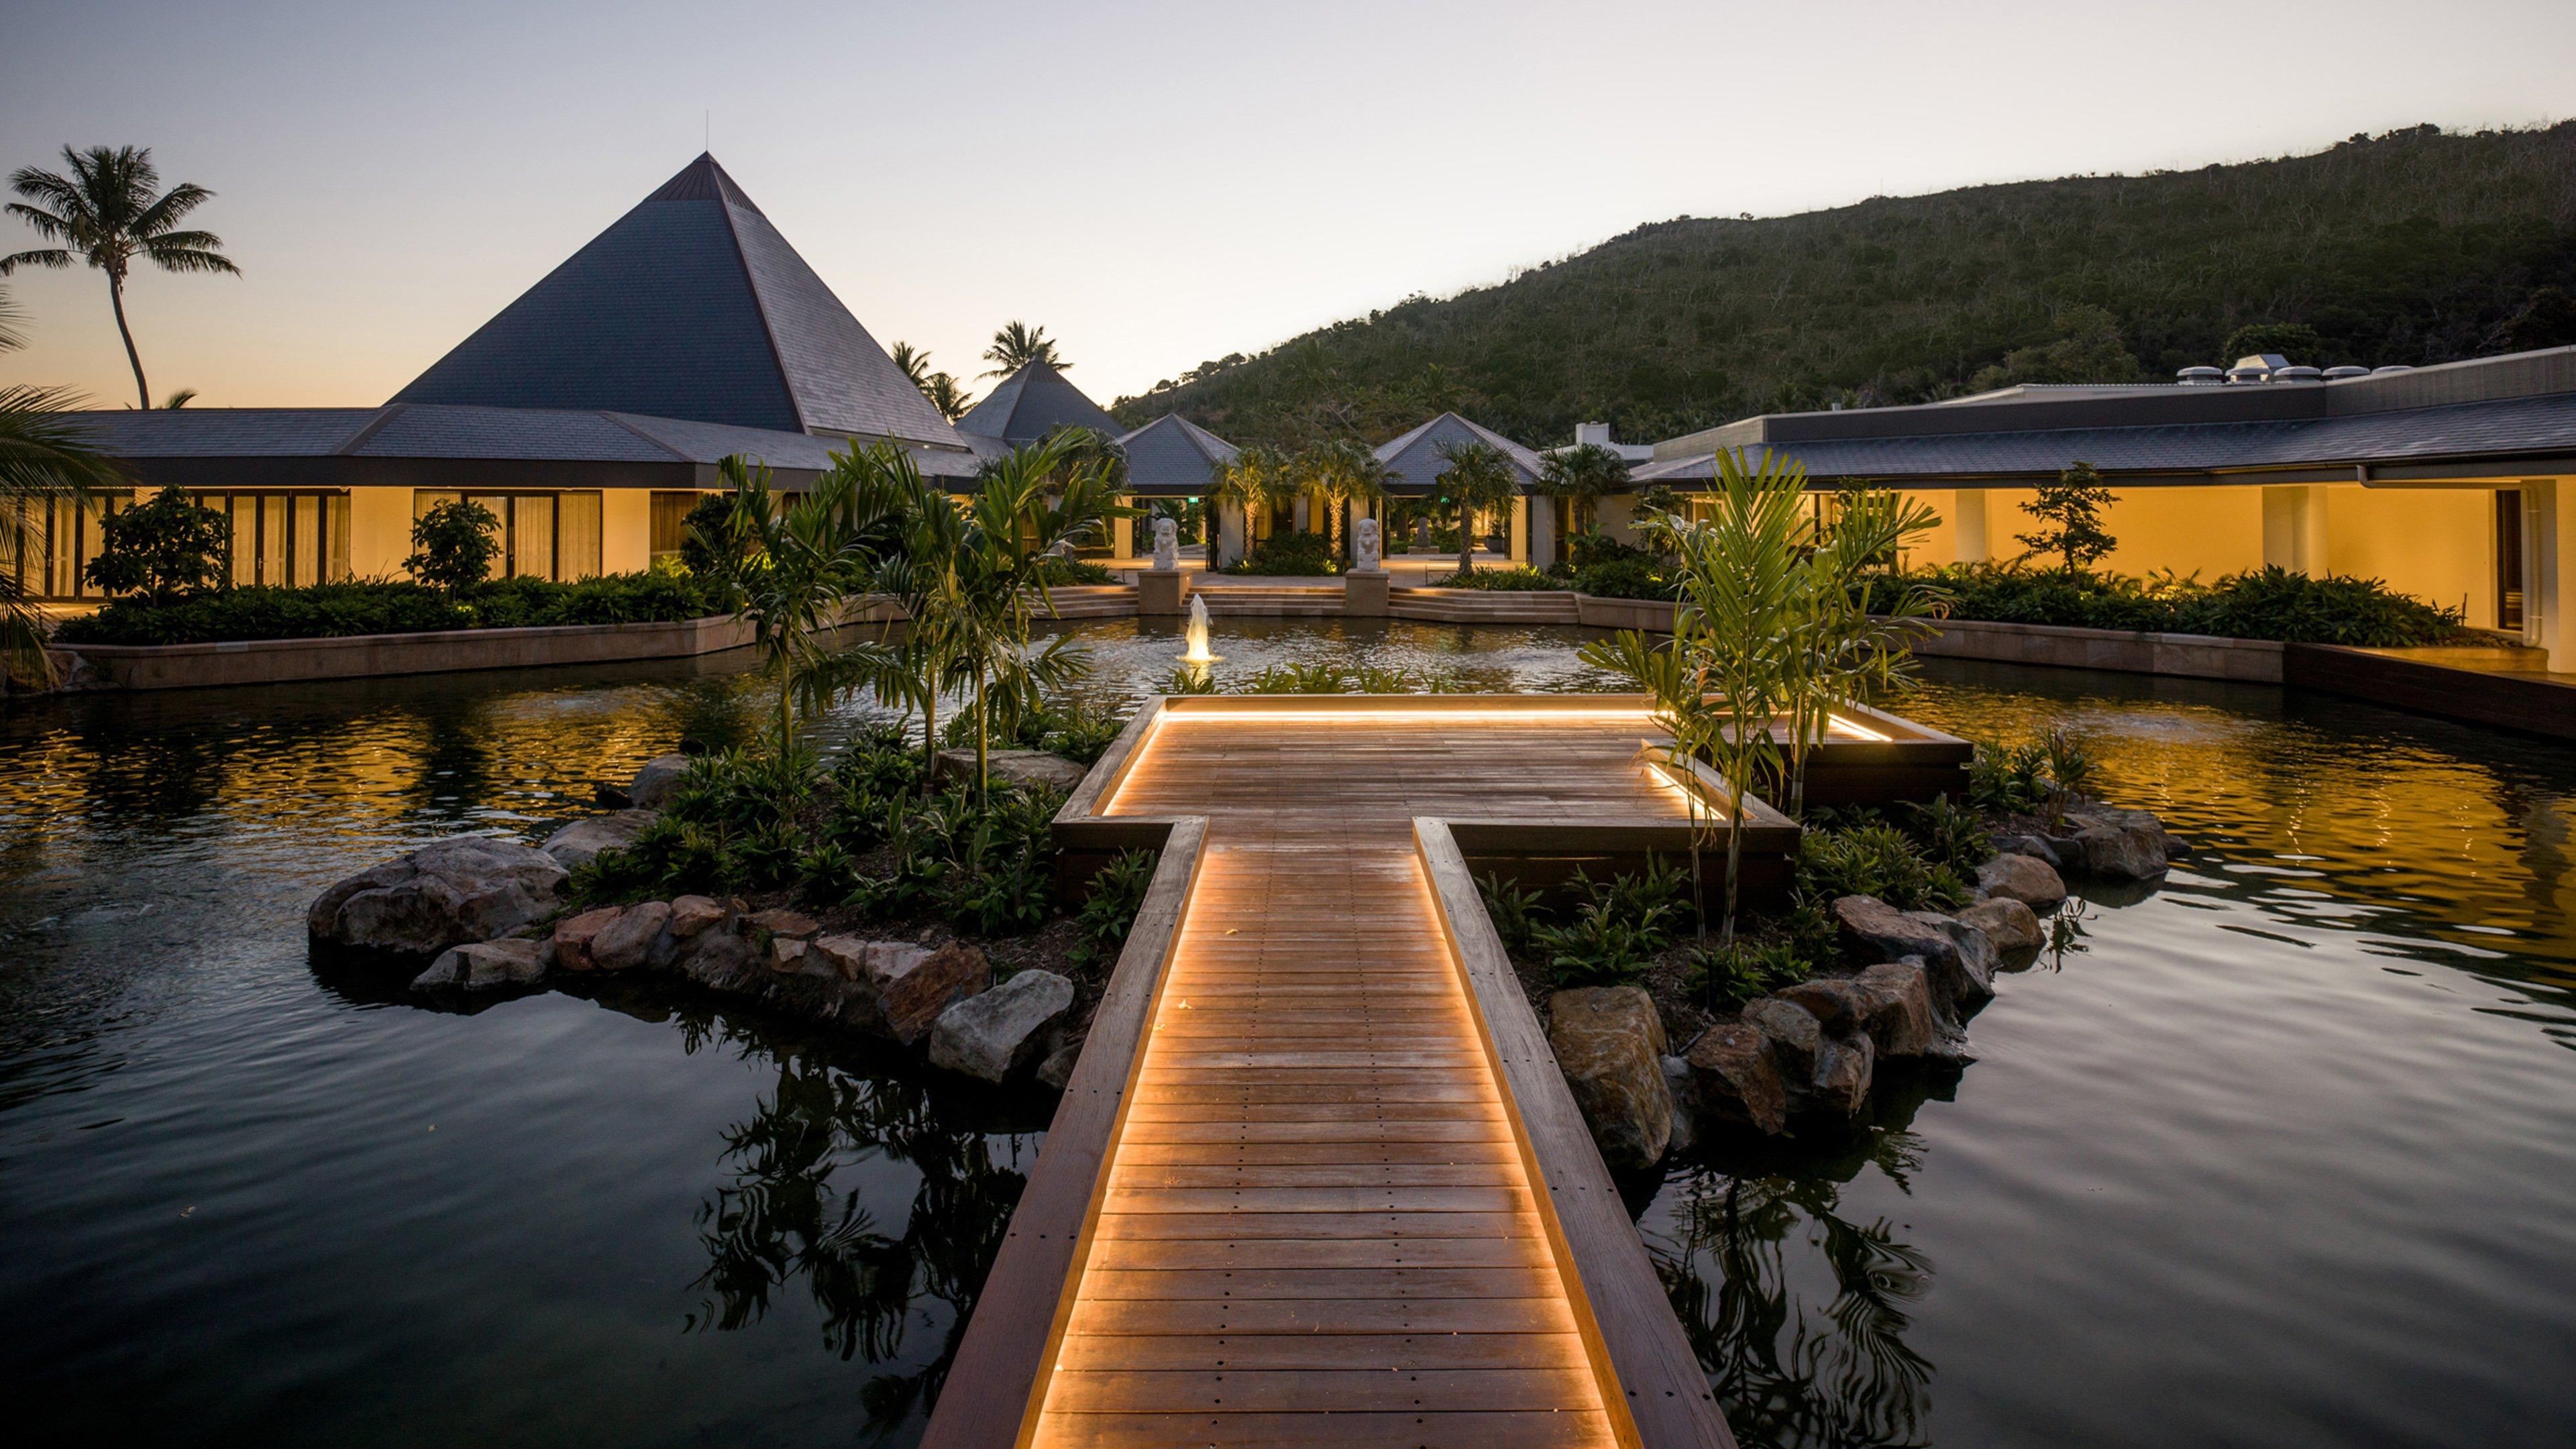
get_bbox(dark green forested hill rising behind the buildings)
[1116,121,2576,446]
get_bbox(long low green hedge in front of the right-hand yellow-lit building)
[1909,565,2475,647]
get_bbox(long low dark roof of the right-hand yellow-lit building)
[1628,392,2576,482]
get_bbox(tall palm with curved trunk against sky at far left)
[0,147,242,410]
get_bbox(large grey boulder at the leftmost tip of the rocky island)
[304,835,564,957]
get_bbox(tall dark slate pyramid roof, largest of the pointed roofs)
[394,155,963,449]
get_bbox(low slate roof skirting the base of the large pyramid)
[72,402,974,477]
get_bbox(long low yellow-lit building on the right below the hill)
[1600,348,2576,667]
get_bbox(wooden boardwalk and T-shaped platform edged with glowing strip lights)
[925,701,1726,1449]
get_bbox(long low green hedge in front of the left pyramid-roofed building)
[62,570,727,645]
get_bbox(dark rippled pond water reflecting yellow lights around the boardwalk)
[0,621,2576,1446]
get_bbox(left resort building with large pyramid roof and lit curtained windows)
[21,155,973,601]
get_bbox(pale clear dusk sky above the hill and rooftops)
[0,0,2576,405]
